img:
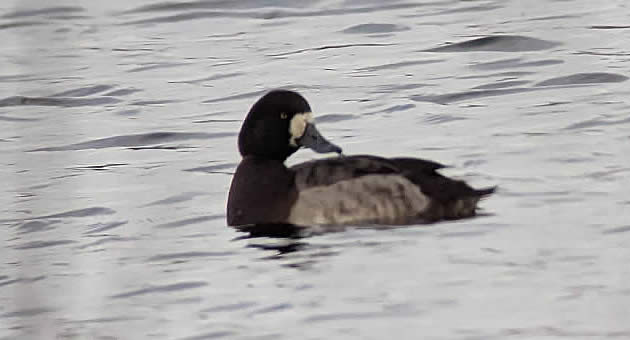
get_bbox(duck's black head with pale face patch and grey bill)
[238,90,341,161]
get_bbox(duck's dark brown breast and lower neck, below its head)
[227,156,297,226]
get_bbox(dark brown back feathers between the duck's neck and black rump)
[290,155,401,191]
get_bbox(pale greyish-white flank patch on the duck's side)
[287,175,429,225]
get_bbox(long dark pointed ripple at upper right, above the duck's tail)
[424,35,561,52]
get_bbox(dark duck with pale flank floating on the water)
[226,89,496,226]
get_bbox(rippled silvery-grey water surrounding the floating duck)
[0,0,630,340]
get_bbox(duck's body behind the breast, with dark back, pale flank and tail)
[290,155,494,224]
